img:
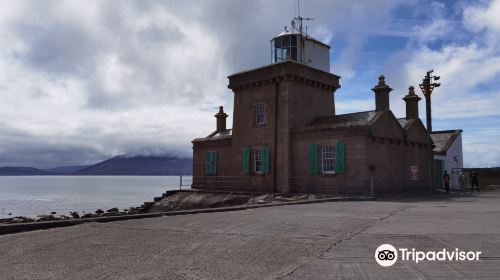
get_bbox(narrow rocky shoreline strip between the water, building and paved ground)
[0,187,498,229]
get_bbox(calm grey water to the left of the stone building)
[0,176,191,218]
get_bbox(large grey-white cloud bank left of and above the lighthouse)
[0,0,414,167]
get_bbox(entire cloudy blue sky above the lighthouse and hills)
[0,0,500,168]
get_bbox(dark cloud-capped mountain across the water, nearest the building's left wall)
[73,155,193,175]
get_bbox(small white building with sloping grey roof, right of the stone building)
[430,129,464,188]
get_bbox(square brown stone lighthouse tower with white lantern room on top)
[228,20,340,192]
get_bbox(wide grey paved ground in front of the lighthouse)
[0,192,500,280]
